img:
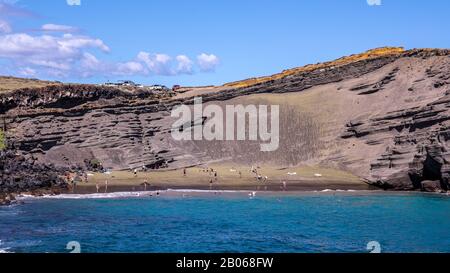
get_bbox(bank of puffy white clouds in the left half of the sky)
[0,0,219,81]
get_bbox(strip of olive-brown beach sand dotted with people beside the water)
[70,164,373,194]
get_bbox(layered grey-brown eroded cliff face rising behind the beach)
[0,49,450,191]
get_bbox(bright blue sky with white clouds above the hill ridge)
[0,0,450,86]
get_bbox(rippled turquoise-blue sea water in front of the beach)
[0,190,450,253]
